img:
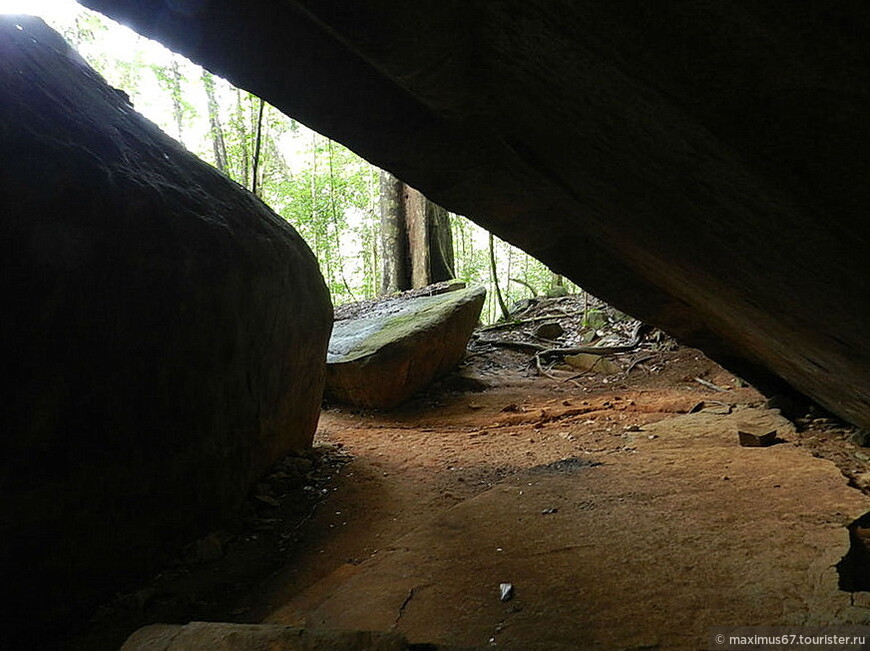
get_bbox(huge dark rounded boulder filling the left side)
[0,17,332,648]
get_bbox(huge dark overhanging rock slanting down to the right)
[85,0,870,427]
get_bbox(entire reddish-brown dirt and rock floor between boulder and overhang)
[58,348,870,649]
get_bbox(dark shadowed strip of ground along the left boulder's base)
[50,445,351,651]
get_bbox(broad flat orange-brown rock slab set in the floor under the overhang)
[268,409,870,651]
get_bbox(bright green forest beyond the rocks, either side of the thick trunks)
[59,7,579,323]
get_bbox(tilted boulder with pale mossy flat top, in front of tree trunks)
[326,287,486,409]
